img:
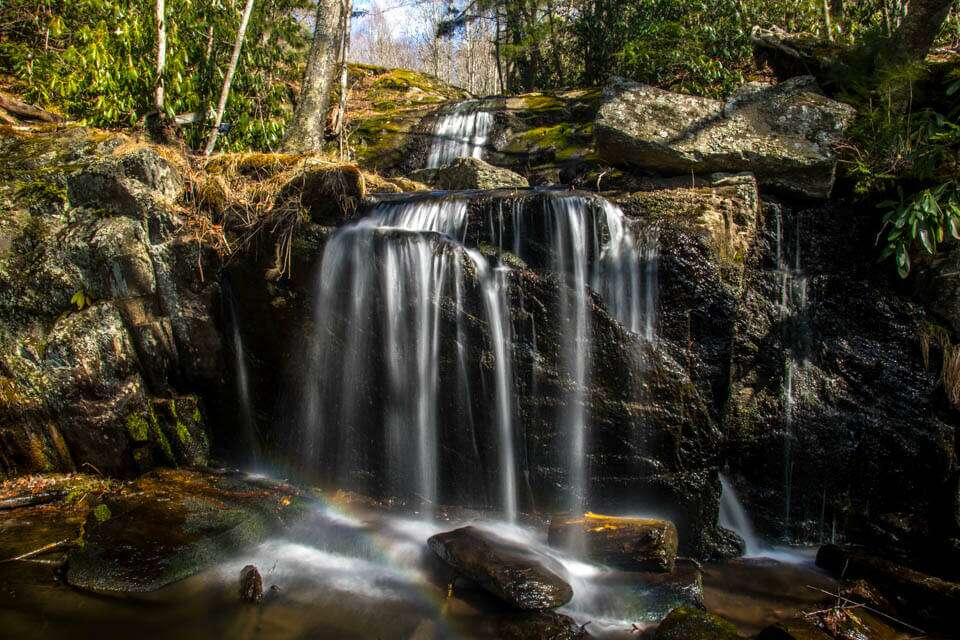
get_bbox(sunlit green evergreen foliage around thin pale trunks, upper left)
[0,0,311,149]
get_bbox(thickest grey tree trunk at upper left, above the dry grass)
[283,0,343,153]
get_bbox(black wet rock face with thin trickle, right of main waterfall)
[725,202,955,555]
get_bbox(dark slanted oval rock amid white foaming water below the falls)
[428,527,573,610]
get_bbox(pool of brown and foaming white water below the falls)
[0,507,832,640]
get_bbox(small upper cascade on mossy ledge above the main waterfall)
[427,100,493,169]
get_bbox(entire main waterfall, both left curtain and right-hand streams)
[301,192,657,521]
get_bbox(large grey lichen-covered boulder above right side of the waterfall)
[595,76,855,198]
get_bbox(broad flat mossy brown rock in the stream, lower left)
[67,471,306,593]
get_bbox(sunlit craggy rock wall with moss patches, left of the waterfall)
[0,127,222,475]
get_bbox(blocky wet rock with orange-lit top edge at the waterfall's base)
[548,513,678,573]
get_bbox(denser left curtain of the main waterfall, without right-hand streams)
[303,198,517,519]
